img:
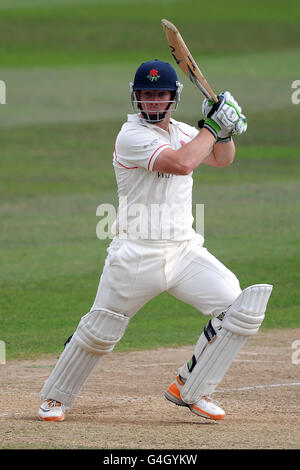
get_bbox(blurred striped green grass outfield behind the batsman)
[0,0,300,359]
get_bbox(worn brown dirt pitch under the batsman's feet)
[0,328,300,449]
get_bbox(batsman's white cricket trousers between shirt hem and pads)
[92,234,241,317]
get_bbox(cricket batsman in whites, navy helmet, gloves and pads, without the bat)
[38,60,272,421]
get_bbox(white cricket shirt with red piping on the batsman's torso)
[112,114,203,241]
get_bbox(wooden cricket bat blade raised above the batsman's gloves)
[161,19,218,103]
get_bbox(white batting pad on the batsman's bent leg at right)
[181,284,272,403]
